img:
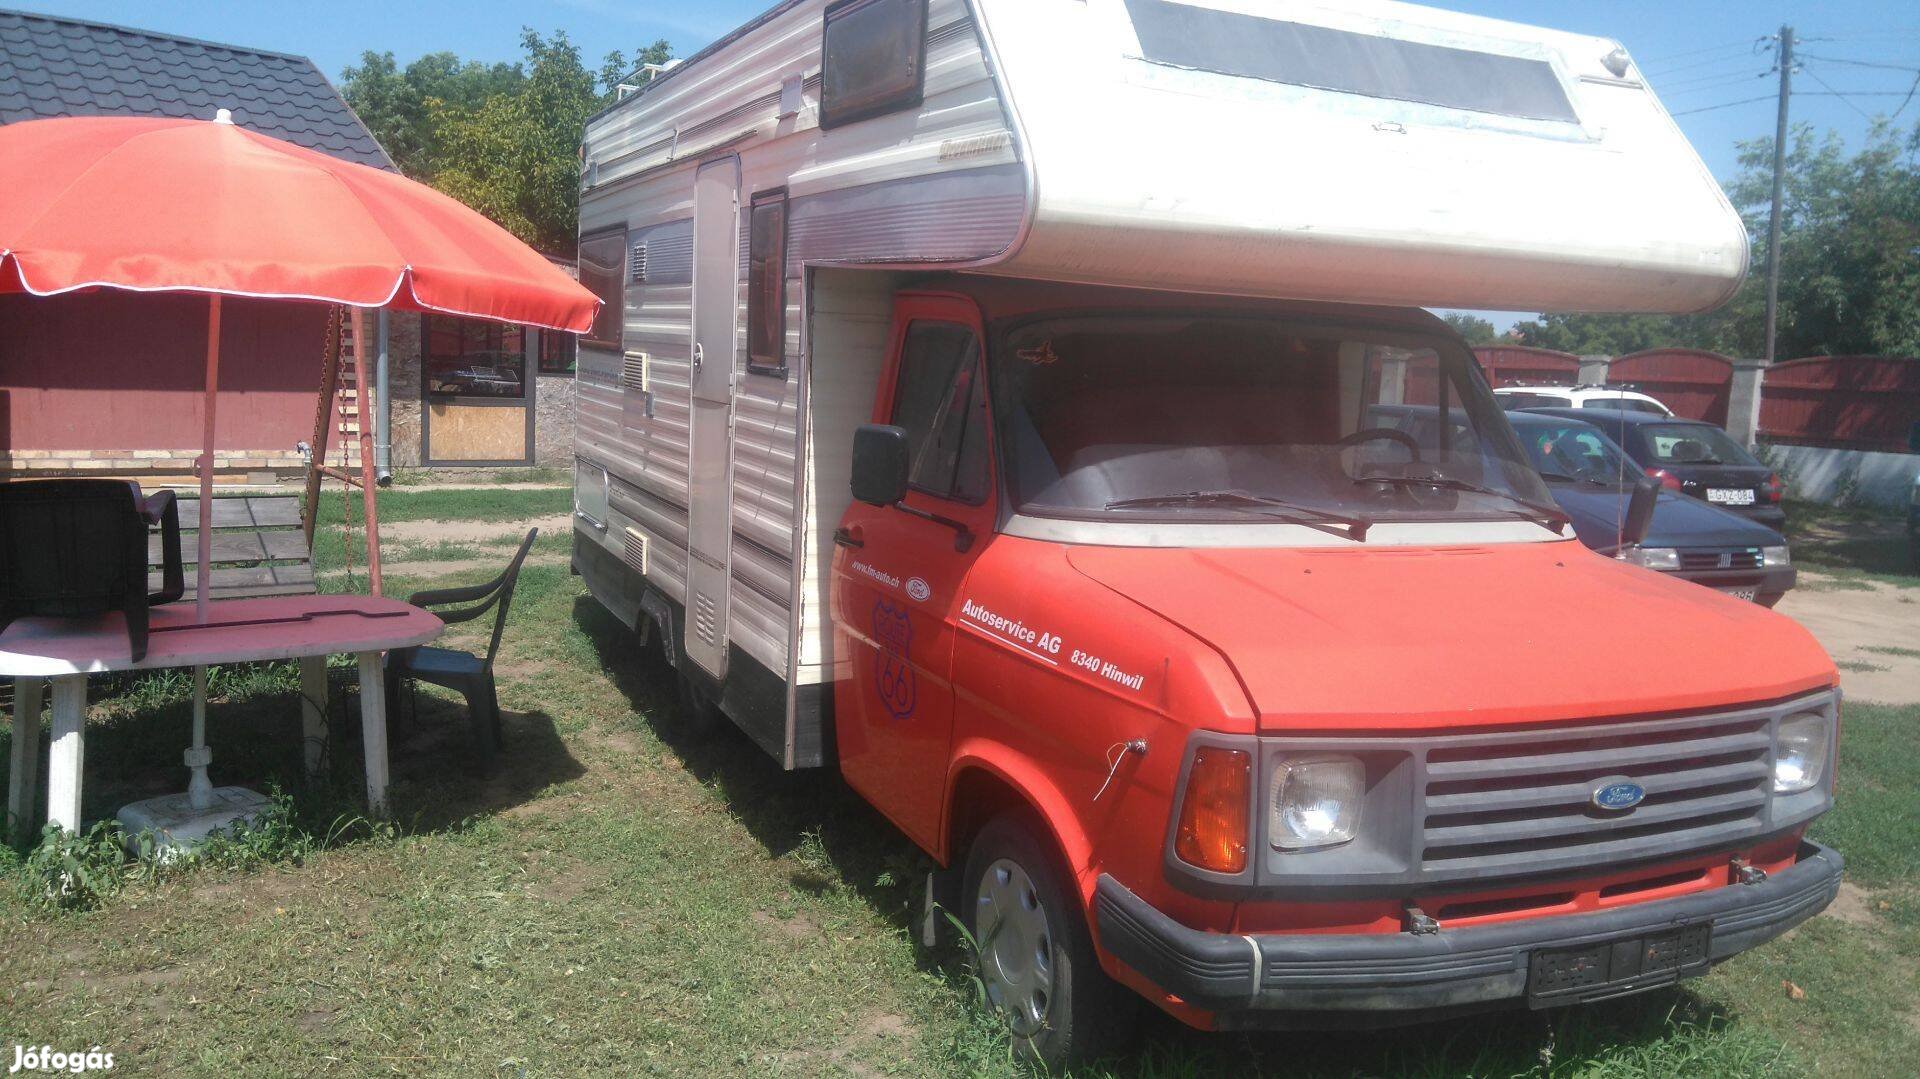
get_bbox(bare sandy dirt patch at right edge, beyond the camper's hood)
[1774,570,1920,705]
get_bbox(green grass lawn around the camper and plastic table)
[0,490,1920,1077]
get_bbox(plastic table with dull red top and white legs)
[0,595,444,831]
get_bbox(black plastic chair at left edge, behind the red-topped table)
[0,480,186,660]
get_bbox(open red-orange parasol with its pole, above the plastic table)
[0,109,599,618]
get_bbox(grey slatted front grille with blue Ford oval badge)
[1421,712,1772,881]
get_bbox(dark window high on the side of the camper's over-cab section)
[820,0,927,127]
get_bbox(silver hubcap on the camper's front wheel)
[973,858,1054,1037]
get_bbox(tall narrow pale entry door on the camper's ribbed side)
[684,157,739,678]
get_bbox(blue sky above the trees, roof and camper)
[18,0,1920,323]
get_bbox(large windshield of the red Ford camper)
[993,313,1557,526]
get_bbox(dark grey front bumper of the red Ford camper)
[1094,843,1841,1027]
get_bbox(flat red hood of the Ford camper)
[1068,540,1837,731]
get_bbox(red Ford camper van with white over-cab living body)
[574,0,1841,1064]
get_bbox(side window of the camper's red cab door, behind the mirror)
[893,321,987,505]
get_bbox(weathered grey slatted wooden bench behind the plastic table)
[146,495,315,603]
